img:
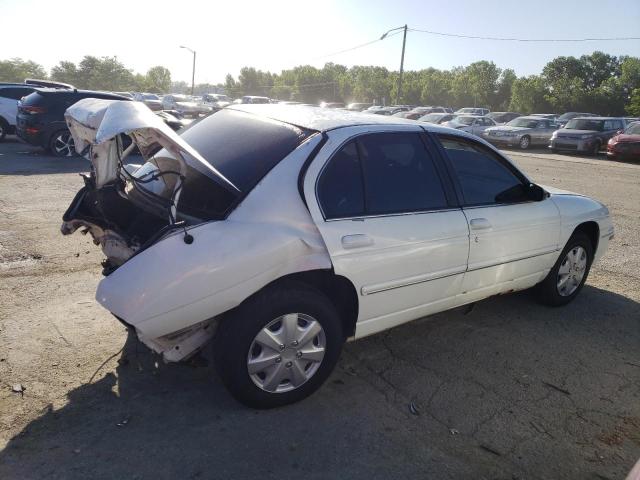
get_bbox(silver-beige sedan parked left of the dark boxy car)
[482,116,558,150]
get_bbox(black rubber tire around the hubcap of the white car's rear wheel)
[213,282,344,409]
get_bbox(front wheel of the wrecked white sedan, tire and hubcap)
[537,232,593,306]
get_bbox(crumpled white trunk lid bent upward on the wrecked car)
[64,98,238,191]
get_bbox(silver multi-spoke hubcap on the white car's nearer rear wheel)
[247,313,326,393]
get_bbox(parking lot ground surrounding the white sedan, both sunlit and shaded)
[0,139,640,480]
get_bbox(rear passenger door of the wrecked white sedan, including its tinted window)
[304,126,469,337]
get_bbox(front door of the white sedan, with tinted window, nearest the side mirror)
[438,135,560,302]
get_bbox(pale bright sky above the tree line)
[0,0,640,83]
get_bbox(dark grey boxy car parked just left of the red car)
[549,117,626,155]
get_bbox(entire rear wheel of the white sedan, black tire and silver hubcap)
[214,282,344,408]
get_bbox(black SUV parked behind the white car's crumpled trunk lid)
[16,88,130,157]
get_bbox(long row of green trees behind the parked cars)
[0,52,640,116]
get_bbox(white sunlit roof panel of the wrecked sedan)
[226,103,430,132]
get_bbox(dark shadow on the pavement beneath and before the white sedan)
[0,286,640,479]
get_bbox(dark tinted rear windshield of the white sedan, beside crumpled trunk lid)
[180,109,313,193]
